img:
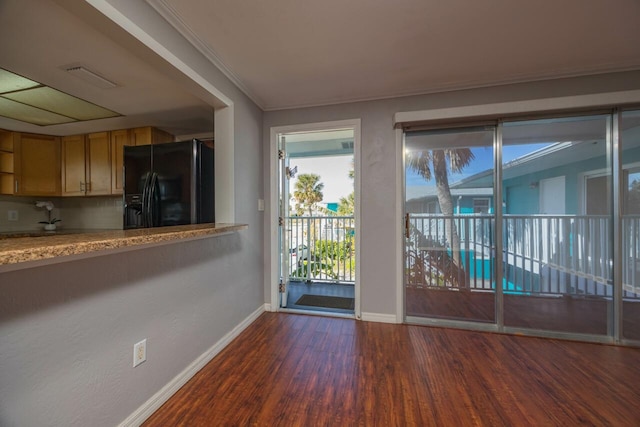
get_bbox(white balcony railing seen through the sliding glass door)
[405,214,640,298]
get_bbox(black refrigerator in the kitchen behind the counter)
[123,139,214,229]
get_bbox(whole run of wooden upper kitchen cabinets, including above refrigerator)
[0,126,175,197]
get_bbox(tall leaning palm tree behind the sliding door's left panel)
[406,148,475,280]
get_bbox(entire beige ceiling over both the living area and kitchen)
[0,0,640,135]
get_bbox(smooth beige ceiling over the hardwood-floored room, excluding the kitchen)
[147,0,640,110]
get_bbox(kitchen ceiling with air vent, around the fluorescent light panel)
[0,0,213,135]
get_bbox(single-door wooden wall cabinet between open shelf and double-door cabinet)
[13,133,61,196]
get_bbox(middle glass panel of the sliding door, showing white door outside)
[501,116,613,335]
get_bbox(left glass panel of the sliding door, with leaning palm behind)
[404,127,496,323]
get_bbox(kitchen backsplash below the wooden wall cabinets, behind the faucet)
[0,196,122,232]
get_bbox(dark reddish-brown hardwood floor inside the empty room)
[145,313,640,426]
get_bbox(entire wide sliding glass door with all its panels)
[404,110,640,345]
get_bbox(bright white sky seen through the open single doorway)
[289,155,353,203]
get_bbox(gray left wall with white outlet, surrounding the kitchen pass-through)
[0,2,265,426]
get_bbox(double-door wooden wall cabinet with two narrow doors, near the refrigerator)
[62,132,111,196]
